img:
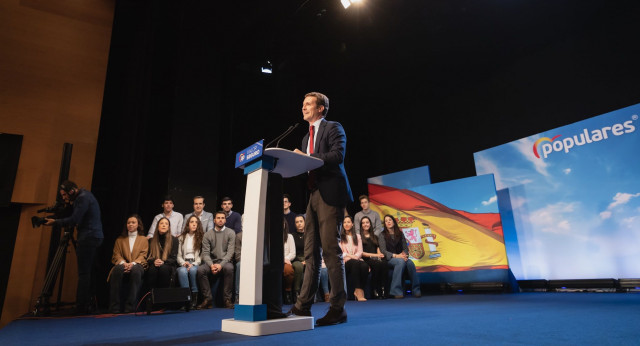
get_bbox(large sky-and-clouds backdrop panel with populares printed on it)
[474,104,640,280]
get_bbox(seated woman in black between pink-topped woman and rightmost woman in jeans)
[360,216,389,299]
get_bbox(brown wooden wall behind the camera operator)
[0,0,115,327]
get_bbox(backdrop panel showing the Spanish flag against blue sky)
[369,172,508,283]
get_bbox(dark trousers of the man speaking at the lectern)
[296,190,347,310]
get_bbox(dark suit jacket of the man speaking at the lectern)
[301,119,353,207]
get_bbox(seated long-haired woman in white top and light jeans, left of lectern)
[178,215,204,309]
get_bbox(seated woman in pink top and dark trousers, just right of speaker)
[340,215,369,302]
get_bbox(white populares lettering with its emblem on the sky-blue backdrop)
[533,114,638,159]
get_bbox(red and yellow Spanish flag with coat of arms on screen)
[369,184,509,272]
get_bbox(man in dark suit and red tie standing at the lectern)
[290,92,353,326]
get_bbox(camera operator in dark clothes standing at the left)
[46,180,104,314]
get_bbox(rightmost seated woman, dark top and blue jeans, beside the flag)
[378,215,422,298]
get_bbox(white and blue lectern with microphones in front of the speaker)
[222,141,324,336]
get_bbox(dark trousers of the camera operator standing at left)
[76,238,102,310]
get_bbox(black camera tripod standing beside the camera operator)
[33,227,76,316]
